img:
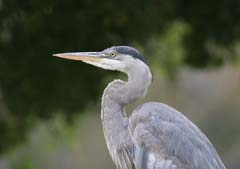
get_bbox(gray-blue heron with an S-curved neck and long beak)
[53,46,225,169]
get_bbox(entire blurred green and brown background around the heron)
[0,0,240,169]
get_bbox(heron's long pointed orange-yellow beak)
[53,52,105,63]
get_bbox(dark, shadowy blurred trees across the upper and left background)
[0,0,240,151]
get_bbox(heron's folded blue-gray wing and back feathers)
[129,102,225,169]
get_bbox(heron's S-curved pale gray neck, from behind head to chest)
[101,61,152,169]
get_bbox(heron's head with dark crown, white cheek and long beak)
[53,46,146,72]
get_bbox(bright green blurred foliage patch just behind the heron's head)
[145,22,189,77]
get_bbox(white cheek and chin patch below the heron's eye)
[83,58,125,71]
